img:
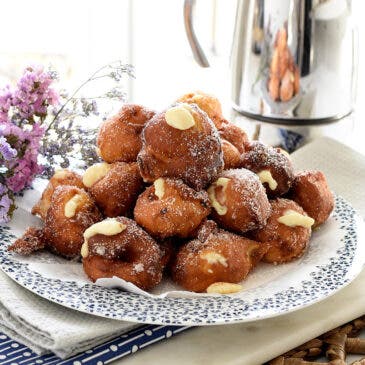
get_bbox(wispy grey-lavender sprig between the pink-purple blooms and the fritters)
[41,61,134,177]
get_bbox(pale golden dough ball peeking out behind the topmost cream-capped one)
[177,91,224,129]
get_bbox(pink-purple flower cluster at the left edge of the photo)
[0,66,58,223]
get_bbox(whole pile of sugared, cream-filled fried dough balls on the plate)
[9,93,334,293]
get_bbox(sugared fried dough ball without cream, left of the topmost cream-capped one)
[97,104,155,163]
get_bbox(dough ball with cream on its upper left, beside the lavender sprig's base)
[83,162,143,217]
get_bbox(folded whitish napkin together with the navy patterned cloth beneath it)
[0,272,187,364]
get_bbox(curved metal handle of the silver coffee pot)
[184,0,209,67]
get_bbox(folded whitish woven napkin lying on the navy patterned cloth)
[0,271,137,356]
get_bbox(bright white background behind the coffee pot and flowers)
[0,0,365,153]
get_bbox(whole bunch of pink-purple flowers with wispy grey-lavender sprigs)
[0,61,134,223]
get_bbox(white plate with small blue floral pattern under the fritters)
[0,196,365,326]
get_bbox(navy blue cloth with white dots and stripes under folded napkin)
[0,325,191,365]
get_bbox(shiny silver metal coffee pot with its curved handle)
[184,0,358,125]
